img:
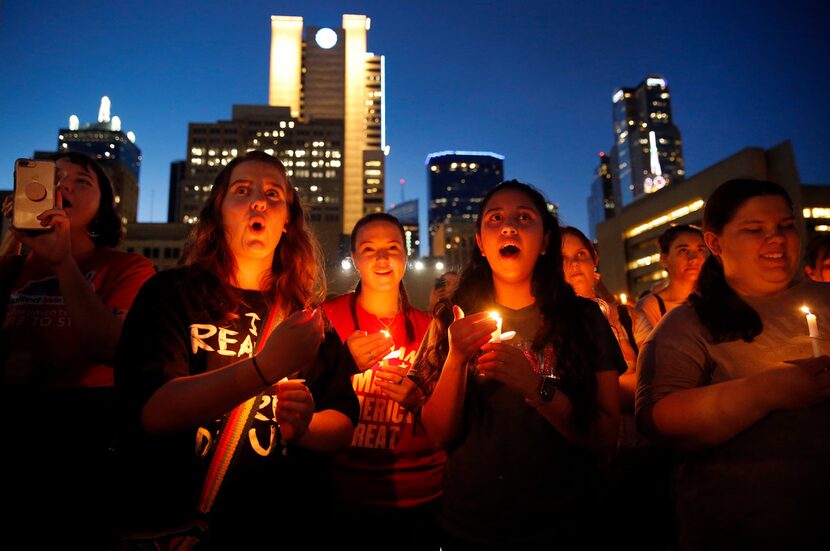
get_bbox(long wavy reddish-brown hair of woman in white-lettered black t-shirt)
[183,151,326,315]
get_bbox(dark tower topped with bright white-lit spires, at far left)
[35,96,141,224]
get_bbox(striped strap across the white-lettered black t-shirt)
[199,308,283,514]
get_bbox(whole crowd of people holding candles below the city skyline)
[0,152,830,551]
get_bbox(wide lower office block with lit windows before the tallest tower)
[171,105,343,260]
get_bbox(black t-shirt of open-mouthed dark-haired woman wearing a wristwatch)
[410,299,625,549]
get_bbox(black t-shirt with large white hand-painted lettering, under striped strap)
[116,268,358,543]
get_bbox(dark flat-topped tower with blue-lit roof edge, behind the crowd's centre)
[426,151,504,266]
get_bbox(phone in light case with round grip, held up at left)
[12,159,57,232]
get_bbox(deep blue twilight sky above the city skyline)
[0,0,830,256]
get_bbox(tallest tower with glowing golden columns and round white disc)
[268,15,388,244]
